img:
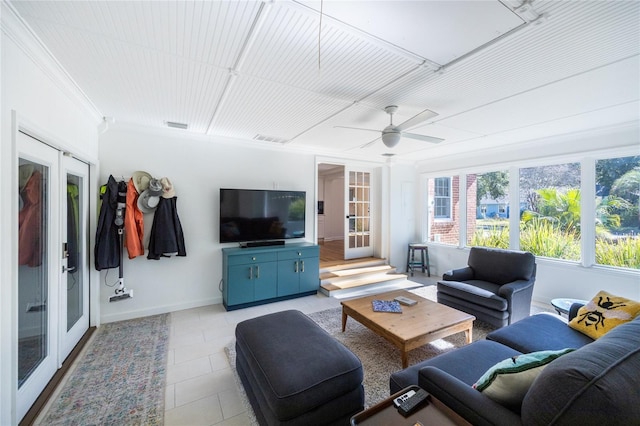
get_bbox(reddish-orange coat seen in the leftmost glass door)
[18,171,43,266]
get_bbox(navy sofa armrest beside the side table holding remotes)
[418,367,522,426]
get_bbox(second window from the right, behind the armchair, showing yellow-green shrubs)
[520,163,581,260]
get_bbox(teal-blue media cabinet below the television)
[222,243,320,311]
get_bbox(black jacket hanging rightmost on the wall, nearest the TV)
[147,197,187,260]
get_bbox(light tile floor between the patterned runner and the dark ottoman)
[165,295,340,426]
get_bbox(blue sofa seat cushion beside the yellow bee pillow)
[487,313,593,353]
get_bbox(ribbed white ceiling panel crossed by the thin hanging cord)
[238,2,419,101]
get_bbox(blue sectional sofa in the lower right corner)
[389,305,640,426]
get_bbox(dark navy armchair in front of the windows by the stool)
[437,247,536,328]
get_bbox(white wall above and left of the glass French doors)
[0,3,99,425]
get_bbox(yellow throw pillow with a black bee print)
[569,291,640,340]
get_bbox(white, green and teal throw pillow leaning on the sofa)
[473,348,575,408]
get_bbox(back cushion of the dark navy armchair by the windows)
[467,247,536,285]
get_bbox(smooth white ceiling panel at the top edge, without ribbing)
[302,1,524,65]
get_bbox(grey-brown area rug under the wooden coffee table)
[225,286,495,424]
